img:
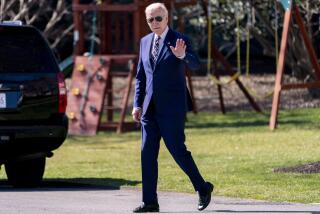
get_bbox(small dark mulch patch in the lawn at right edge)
[274,162,320,174]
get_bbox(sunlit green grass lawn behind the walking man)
[0,109,320,203]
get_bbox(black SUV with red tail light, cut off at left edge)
[0,23,68,186]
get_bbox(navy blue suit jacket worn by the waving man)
[134,29,200,118]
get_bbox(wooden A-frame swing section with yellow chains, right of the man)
[207,0,320,130]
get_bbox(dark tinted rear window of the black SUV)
[0,27,57,73]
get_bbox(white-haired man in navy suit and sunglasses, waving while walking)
[132,3,213,213]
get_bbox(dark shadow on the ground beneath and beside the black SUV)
[0,178,141,192]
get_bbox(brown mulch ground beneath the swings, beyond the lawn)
[192,74,320,112]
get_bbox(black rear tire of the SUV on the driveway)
[5,157,46,187]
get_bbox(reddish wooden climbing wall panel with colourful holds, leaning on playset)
[67,55,110,135]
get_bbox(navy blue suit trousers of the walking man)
[141,101,205,204]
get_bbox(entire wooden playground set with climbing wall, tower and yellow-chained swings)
[67,0,320,135]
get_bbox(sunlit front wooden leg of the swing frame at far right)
[269,7,292,130]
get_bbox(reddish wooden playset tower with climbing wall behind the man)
[67,0,197,135]
